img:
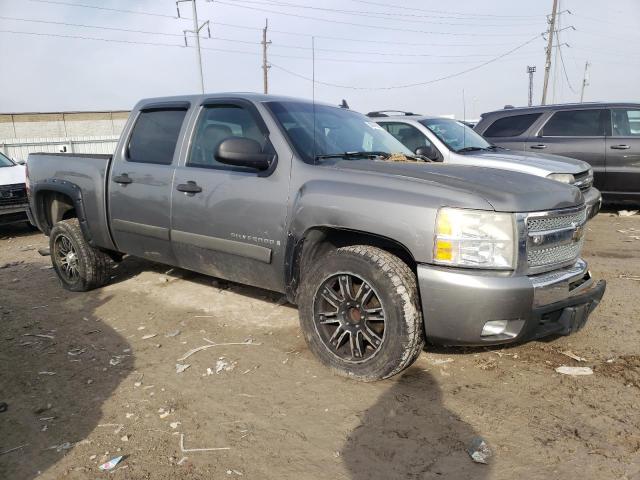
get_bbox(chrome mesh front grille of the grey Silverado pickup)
[525,207,587,273]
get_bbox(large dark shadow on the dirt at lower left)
[0,263,134,480]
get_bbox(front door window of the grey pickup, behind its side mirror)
[187,105,271,172]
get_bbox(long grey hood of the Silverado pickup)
[334,160,584,212]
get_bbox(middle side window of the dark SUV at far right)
[541,109,608,137]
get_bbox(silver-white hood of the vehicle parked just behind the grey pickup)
[463,150,590,177]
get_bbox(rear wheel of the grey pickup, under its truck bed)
[49,218,113,292]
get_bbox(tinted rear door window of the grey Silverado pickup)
[127,109,187,165]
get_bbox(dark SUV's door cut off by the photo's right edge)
[605,108,640,198]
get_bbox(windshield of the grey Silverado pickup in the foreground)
[268,102,412,163]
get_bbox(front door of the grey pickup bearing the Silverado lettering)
[171,100,291,290]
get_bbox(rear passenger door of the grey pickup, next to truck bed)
[109,104,188,264]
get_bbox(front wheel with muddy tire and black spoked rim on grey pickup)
[298,245,424,382]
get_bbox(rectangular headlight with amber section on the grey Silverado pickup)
[433,207,515,269]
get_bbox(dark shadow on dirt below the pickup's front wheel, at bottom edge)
[341,367,491,480]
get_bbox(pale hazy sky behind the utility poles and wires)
[0,0,640,119]
